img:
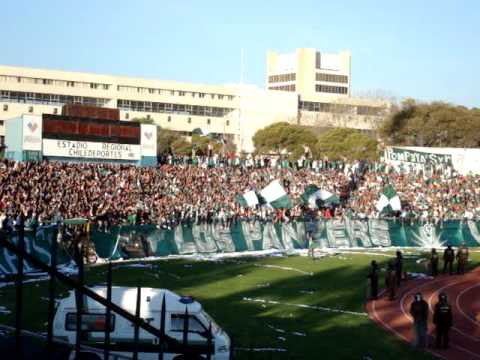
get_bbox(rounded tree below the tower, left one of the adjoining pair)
[253,122,317,159]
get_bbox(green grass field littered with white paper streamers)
[0,250,480,360]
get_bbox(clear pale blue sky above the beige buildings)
[0,0,480,107]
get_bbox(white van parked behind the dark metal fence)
[53,286,230,360]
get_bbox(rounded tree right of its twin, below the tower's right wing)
[314,128,378,160]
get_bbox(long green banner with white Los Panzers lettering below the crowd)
[92,219,480,259]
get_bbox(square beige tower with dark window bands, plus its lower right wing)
[266,48,390,130]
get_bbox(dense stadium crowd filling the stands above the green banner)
[0,160,480,227]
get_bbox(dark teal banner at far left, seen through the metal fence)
[0,225,70,275]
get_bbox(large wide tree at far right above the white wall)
[379,99,480,147]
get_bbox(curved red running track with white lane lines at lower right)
[366,267,480,360]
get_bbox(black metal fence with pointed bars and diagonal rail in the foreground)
[0,226,221,359]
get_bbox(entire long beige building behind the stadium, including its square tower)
[0,49,385,152]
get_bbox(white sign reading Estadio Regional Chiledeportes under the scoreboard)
[43,139,140,160]
